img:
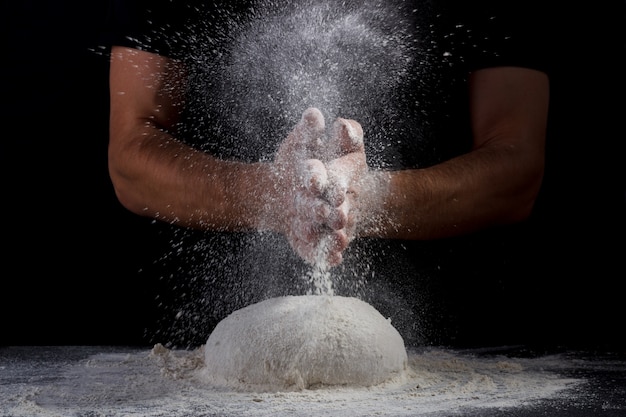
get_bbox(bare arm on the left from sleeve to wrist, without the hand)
[109,47,275,230]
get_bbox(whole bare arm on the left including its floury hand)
[109,47,352,265]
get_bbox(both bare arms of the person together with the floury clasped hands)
[109,47,549,266]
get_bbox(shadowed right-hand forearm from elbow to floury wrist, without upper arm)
[358,148,543,240]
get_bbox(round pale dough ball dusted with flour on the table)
[204,295,408,391]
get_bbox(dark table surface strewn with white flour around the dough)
[0,346,626,417]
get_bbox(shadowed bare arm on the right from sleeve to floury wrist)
[357,67,548,239]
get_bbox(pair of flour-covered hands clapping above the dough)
[274,108,367,267]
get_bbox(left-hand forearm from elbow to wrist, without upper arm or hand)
[109,123,275,231]
